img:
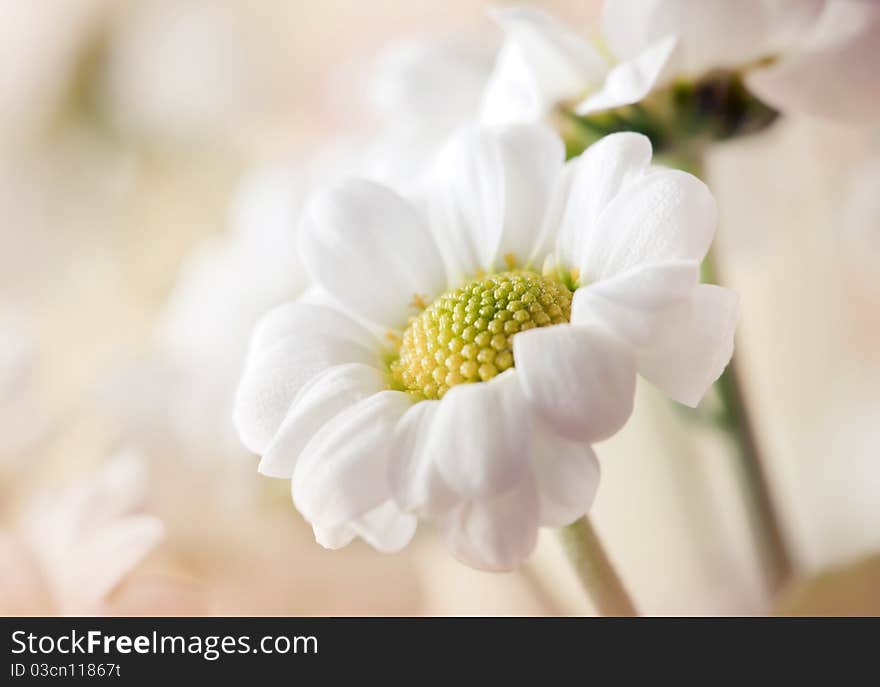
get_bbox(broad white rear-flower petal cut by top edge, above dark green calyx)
[602,0,823,76]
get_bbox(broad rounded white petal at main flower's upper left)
[300,180,445,328]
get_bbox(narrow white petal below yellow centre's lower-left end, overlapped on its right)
[389,401,458,517]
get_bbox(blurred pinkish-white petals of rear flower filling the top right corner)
[602,0,880,123]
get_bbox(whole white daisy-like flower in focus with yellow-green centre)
[235,126,738,570]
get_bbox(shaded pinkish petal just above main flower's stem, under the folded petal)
[532,420,599,527]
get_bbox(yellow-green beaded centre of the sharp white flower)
[390,270,571,399]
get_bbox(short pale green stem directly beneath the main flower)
[559,515,638,617]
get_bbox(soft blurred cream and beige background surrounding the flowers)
[0,0,880,615]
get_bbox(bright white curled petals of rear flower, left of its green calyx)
[481,7,676,124]
